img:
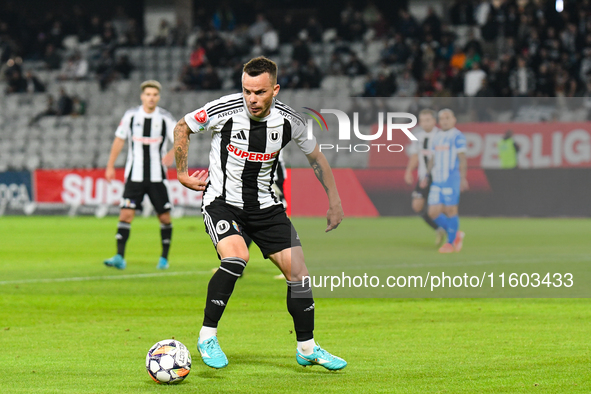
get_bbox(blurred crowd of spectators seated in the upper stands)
[0,0,591,97]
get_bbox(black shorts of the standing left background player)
[119,181,172,214]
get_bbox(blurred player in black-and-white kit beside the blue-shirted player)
[404,109,445,245]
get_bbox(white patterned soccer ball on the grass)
[146,339,191,384]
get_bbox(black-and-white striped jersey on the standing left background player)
[115,105,176,182]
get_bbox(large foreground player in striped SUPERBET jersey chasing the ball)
[174,57,347,370]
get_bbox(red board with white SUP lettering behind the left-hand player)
[33,169,202,206]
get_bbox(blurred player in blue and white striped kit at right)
[422,109,468,253]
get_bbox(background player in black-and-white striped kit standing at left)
[104,80,176,269]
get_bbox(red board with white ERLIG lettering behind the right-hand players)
[369,122,591,169]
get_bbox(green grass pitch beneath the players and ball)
[0,217,591,394]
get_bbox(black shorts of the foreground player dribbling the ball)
[202,199,302,258]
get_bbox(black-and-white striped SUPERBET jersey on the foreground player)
[185,93,316,210]
